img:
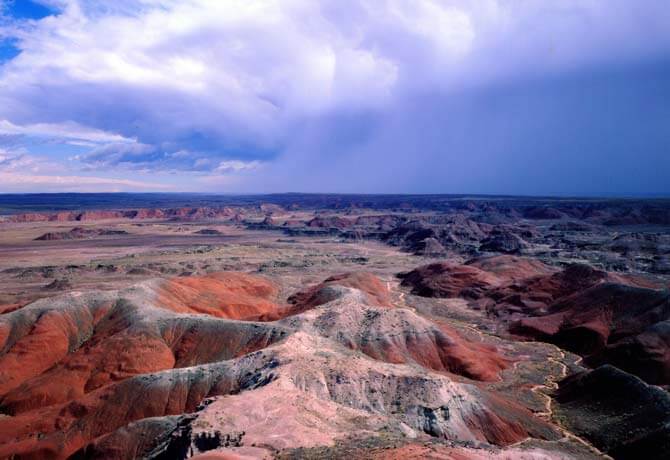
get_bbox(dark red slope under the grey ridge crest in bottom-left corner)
[0,363,249,458]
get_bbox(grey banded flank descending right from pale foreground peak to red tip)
[272,335,554,444]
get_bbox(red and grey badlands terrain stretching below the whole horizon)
[0,194,670,460]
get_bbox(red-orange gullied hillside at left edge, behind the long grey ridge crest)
[1,286,287,414]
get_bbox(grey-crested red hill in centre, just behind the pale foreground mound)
[289,273,509,381]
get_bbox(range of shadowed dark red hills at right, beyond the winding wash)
[400,256,670,384]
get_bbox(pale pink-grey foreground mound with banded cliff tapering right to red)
[136,332,557,456]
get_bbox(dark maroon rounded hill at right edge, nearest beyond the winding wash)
[511,283,670,384]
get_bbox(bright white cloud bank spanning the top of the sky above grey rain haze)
[0,0,670,110]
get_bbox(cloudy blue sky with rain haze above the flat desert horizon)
[0,0,670,196]
